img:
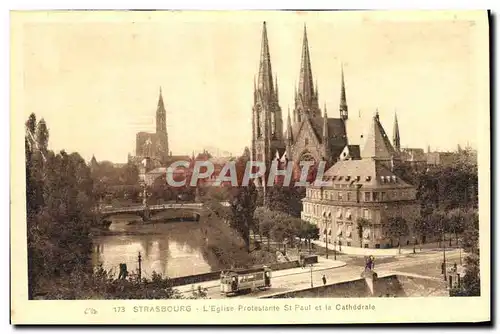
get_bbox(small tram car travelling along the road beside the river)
[220,266,271,296]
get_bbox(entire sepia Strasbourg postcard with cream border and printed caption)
[10,11,491,324]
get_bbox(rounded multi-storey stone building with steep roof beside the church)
[302,113,419,248]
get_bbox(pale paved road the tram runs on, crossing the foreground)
[176,251,463,299]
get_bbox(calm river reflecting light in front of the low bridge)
[92,215,221,278]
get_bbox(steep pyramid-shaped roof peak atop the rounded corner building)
[361,112,396,160]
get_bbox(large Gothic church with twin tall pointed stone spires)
[251,22,359,175]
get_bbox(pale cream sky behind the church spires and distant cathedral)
[15,12,488,162]
